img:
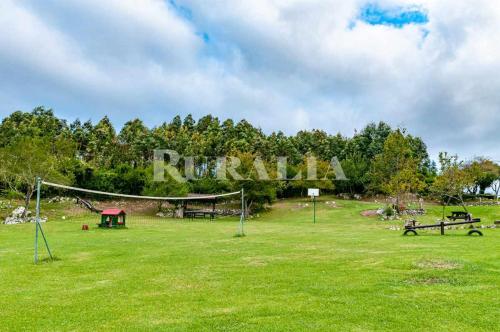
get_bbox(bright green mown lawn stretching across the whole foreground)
[0,200,500,331]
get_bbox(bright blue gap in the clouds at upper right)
[359,3,429,28]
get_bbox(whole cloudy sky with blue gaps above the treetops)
[0,0,500,160]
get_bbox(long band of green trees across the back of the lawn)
[0,107,500,208]
